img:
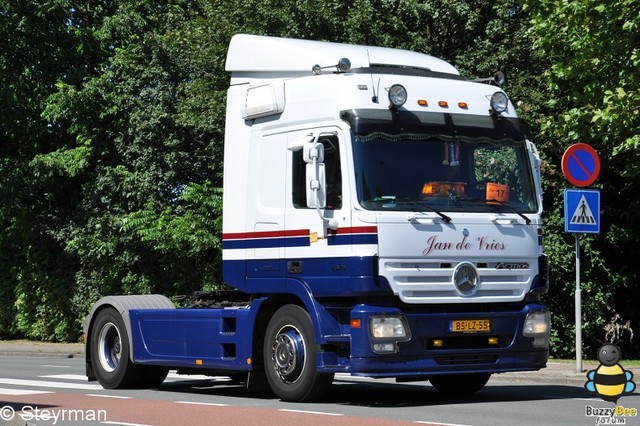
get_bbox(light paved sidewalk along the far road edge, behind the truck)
[0,340,640,387]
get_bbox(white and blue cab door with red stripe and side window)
[284,127,352,295]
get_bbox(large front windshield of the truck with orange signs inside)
[343,110,538,213]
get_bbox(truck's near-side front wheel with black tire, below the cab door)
[263,305,333,402]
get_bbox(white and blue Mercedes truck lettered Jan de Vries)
[83,34,550,401]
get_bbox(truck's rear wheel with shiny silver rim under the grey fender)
[91,308,145,389]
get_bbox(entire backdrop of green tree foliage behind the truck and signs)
[0,0,640,356]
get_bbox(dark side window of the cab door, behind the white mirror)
[291,134,342,209]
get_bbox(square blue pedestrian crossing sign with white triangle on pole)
[564,189,600,234]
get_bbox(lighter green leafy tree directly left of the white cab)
[37,1,226,322]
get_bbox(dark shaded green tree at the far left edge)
[0,0,91,340]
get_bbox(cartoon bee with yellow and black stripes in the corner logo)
[584,344,636,404]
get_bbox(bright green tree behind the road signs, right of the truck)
[526,0,640,356]
